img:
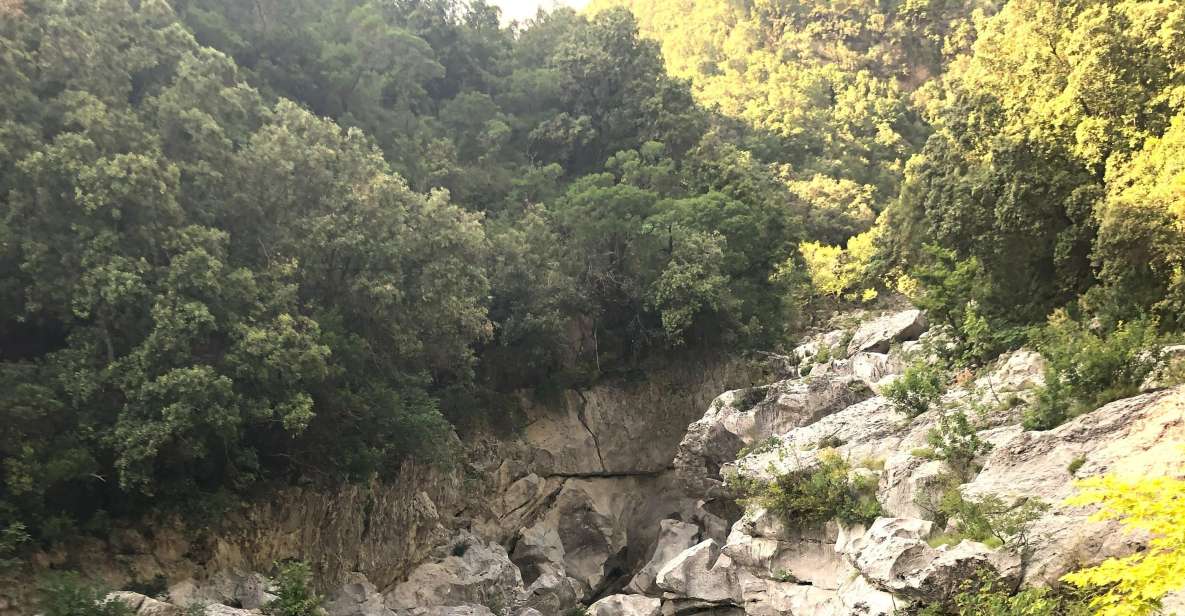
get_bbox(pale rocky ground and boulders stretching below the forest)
[9,310,1185,616]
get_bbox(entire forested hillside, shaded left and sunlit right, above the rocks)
[0,0,1185,606]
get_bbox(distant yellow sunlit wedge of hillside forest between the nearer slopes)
[593,0,994,219]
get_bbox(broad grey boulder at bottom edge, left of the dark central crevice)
[386,533,525,611]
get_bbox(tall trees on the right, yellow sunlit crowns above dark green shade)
[889,0,1185,327]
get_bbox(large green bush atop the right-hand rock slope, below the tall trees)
[1024,310,1164,430]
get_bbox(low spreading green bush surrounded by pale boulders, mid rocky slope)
[754,451,884,527]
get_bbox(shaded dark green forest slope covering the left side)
[0,0,829,539]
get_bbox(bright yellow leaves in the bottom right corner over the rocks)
[1062,476,1185,616]
